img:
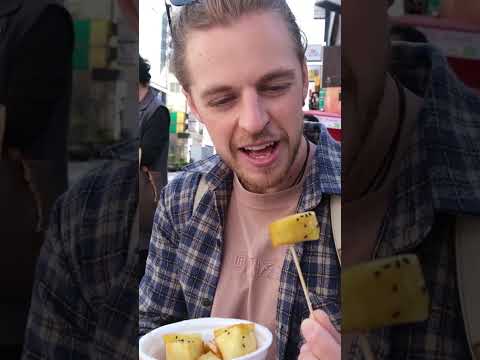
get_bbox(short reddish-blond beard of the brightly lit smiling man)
[224,127,303,194]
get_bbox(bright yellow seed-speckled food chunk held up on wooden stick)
[269,211,320,247]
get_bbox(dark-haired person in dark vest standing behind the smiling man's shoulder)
[138,56,170,188]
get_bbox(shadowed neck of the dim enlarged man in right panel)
[342,76,422,202]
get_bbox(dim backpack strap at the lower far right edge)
[455,216,480,360]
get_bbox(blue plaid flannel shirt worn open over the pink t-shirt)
[139,124,340,359]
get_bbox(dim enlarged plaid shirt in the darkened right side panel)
[347,43,480,360]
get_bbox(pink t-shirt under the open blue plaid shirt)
[211,141,314,360]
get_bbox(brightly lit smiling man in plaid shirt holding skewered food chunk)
[139,0,340,359]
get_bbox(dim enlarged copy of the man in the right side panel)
[342,0,480,360]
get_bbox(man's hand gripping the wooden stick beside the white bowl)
[298,310,341,360]
